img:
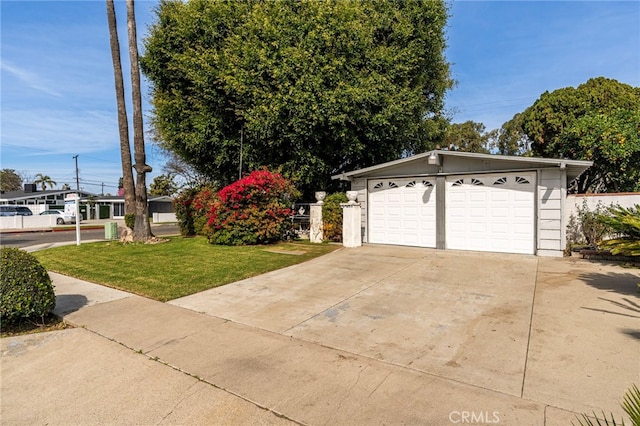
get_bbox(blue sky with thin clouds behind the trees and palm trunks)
[0,0,640,193]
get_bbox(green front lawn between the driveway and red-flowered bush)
[33,237,339,302]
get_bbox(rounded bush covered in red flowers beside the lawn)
[206,168,299,245]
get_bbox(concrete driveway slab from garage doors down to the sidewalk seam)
[169,245,640,422]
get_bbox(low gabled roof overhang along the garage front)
[331,150,593,181]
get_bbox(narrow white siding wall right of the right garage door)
[537,169,567,257]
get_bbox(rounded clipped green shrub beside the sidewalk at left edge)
[0,247,56,323]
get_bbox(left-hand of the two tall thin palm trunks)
[107,0,136,214]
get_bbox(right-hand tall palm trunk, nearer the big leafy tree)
[127,0,153,241]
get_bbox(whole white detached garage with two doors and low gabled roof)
[332,150,592,257]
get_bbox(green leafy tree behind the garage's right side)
[516,77,640,192]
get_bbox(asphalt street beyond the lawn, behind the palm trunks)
[0,224,180,248]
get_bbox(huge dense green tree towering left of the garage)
[141,0,452,196]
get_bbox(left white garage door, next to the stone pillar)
[369,178,436,247]
